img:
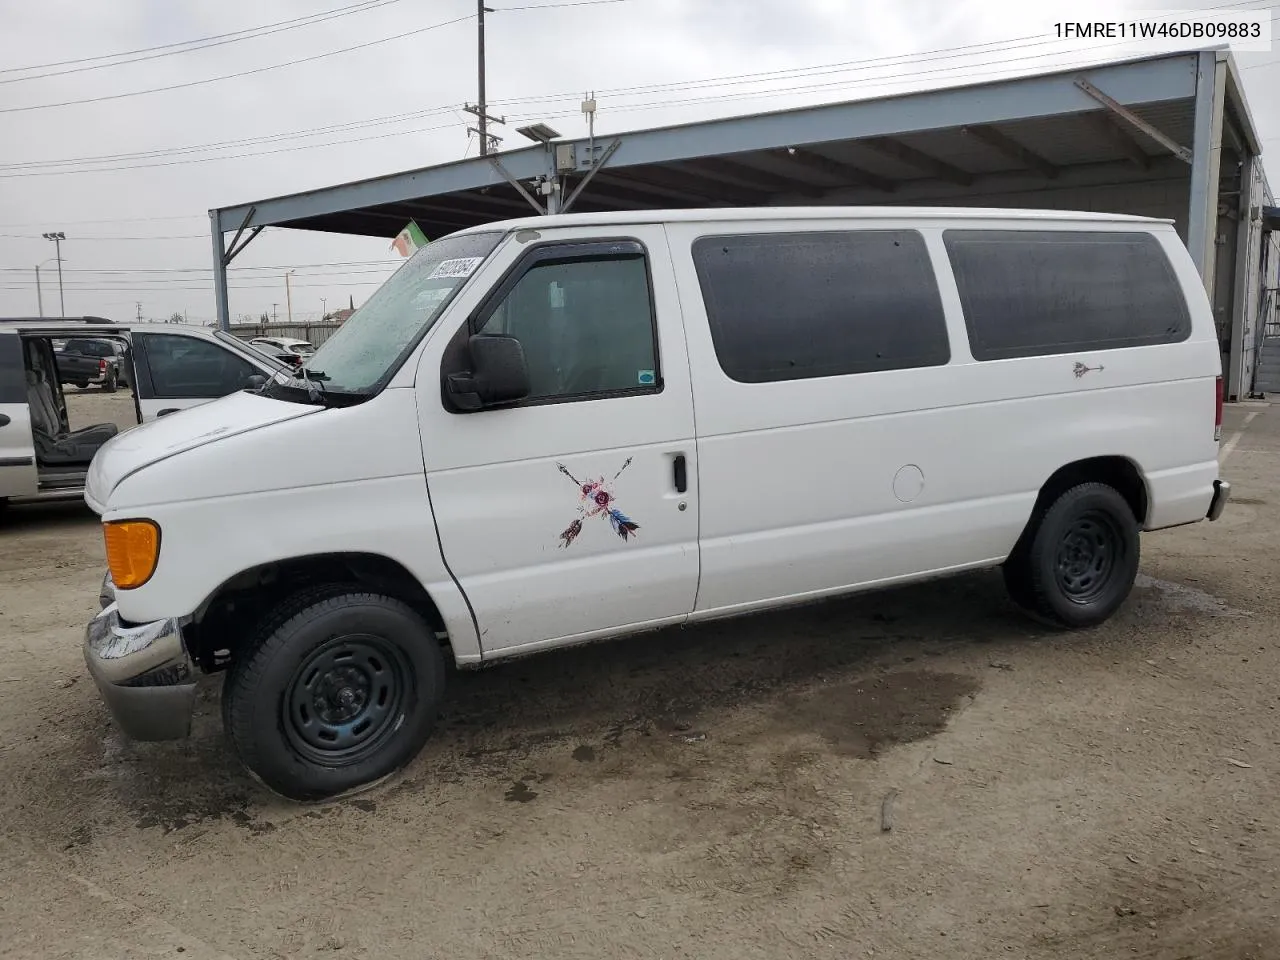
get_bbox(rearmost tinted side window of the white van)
[943,230,1190,360]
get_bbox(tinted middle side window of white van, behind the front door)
[692,230,951,383]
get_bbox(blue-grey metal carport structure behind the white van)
[210,50,1275,398]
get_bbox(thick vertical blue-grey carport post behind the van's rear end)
[1187,51,1226,291]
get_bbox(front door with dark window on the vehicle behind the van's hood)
[133,332,268,422]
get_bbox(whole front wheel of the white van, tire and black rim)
[223,590,444,800]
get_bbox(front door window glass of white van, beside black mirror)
[474,243,660,401]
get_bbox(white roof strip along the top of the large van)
[451,206,1174,236]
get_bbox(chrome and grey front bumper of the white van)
[84,579,196,740]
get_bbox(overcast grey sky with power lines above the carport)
[0,0,1280,324]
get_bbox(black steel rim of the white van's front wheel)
[283,634,413,767]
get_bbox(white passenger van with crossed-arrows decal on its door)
[84,207,1229,800]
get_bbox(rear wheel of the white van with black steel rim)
[1004,483,1139,627]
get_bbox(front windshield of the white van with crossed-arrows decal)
[289,232,503,393]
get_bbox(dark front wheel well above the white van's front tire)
[183,553,448,671]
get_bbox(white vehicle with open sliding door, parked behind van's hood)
[0,317,284,508]
